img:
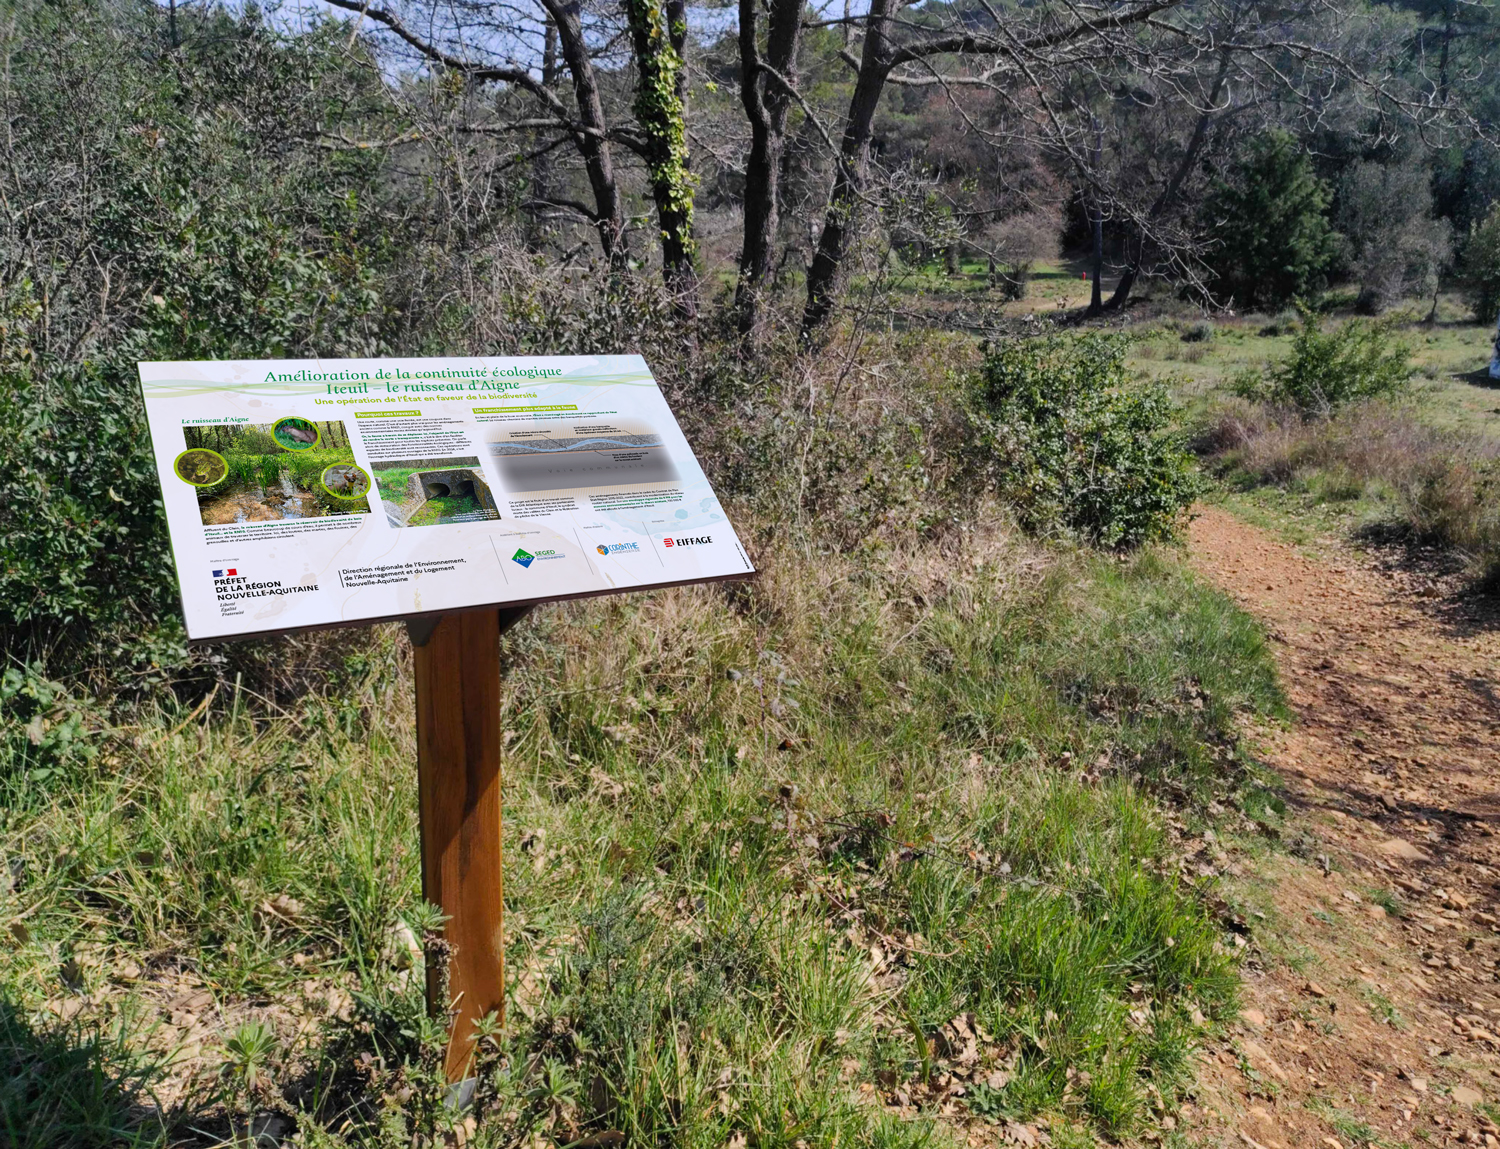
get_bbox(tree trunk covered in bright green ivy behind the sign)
[624,0,698,318]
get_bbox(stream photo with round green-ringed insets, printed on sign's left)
[176,417,371,527]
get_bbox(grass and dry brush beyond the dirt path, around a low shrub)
[1158,300,1500,587]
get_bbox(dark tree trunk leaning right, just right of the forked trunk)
[803,0,900,339]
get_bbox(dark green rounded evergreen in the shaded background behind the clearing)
[1205,132,1340,306]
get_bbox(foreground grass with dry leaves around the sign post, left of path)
[0,536,1281,1149]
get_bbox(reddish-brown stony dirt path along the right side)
[1182,507,1500,1149]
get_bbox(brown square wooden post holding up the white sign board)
[407,606,531,1082]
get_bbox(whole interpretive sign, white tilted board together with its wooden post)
[140,356,753,1083]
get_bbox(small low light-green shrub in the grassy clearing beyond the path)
[1269,309,1413,416]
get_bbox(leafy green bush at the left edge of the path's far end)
[975,335,1199,548]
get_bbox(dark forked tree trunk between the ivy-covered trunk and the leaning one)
[735,0,803,347]
